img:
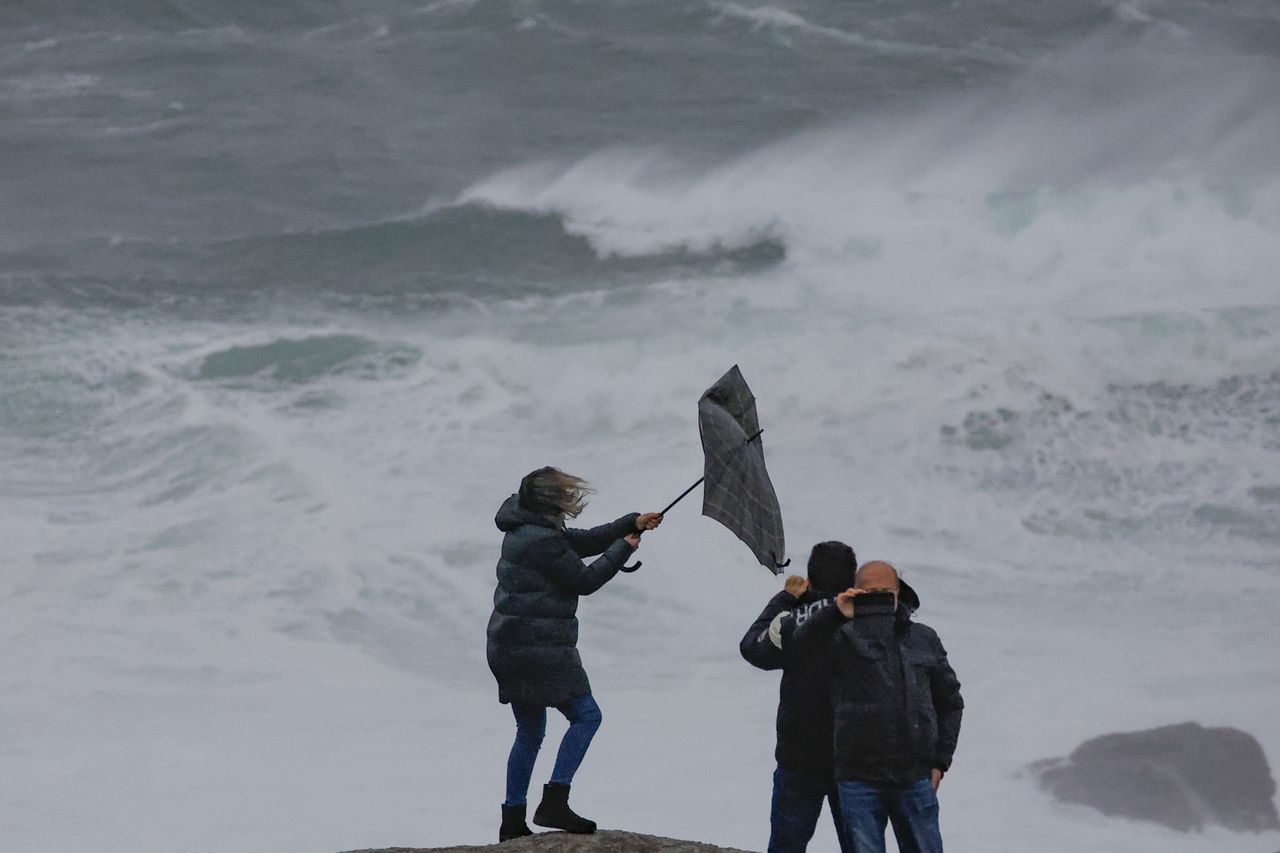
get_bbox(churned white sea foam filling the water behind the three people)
[0,244,1280,852]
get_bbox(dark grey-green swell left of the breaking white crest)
[0,202,785,310]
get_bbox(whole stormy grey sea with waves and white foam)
[0,0,1280,853]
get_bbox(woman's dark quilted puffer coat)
[488,494,637,708]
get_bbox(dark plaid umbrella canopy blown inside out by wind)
[698,365,786,574]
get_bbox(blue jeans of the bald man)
[837,779,942,853]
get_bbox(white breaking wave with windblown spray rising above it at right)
[460,28,1280,330]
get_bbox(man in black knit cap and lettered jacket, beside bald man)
[739,542,856,853]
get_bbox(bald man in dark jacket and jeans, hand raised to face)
[791,561,964,853]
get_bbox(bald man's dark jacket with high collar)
[791,599,964,786]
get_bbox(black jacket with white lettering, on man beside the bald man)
[739,590,835,784]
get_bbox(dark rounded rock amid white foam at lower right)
[1029,722,1280,833]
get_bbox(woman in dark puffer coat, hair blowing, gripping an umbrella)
[488,467,662,841]
